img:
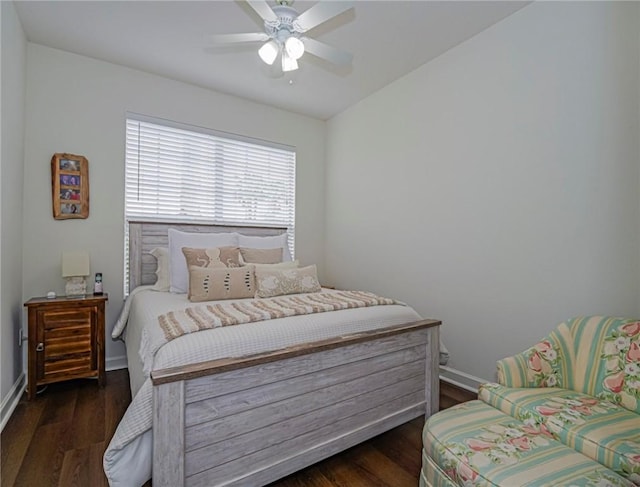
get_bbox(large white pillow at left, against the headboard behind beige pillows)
[169,228,238,293]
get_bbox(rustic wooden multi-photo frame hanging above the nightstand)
[51,153,89,220]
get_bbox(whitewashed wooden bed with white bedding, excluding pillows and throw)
[104,222,440,487]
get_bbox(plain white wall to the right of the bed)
[326,2,640,386]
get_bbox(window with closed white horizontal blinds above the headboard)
[125,114,296,292]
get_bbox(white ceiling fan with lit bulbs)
[210,0,353,72]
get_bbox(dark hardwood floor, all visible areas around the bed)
[0,370,474,487]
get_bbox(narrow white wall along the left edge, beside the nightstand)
[0,2,27,425]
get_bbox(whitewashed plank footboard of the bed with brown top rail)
[151,320,440,487]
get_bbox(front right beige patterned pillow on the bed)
[255,265,321,298]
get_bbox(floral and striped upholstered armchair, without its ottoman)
[479,316,640,485]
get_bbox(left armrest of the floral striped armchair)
[498,337,563,387]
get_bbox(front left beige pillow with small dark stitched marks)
[189,266,256,302]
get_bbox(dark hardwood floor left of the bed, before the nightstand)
[0,370,131,487]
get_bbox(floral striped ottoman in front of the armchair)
[423,400,633,487]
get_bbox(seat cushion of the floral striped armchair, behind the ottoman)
[478,384,640,485]
